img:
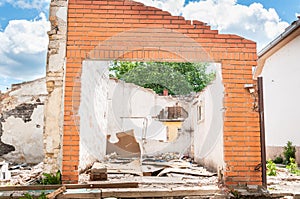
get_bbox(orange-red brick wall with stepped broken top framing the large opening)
[62,0,262,185]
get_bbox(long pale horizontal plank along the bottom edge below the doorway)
[58,187,219,199]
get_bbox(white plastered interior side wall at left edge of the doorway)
[77,61,108,170]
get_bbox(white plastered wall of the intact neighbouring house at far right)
[261,36,300,146]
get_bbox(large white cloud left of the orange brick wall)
[0,13,50,81]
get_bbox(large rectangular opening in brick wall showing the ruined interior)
[76,60,224,187]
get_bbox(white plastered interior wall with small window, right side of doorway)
[193,64,224,171]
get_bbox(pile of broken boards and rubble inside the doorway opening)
[79,153,218,188]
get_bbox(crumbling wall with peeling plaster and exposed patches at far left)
[0,78,47,163]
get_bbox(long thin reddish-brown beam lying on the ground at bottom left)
[0,182,138,191]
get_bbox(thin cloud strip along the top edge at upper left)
[0,0,50,10]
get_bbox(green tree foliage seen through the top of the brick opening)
[110,61,215,95]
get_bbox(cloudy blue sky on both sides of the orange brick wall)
[0,0,300,91]
